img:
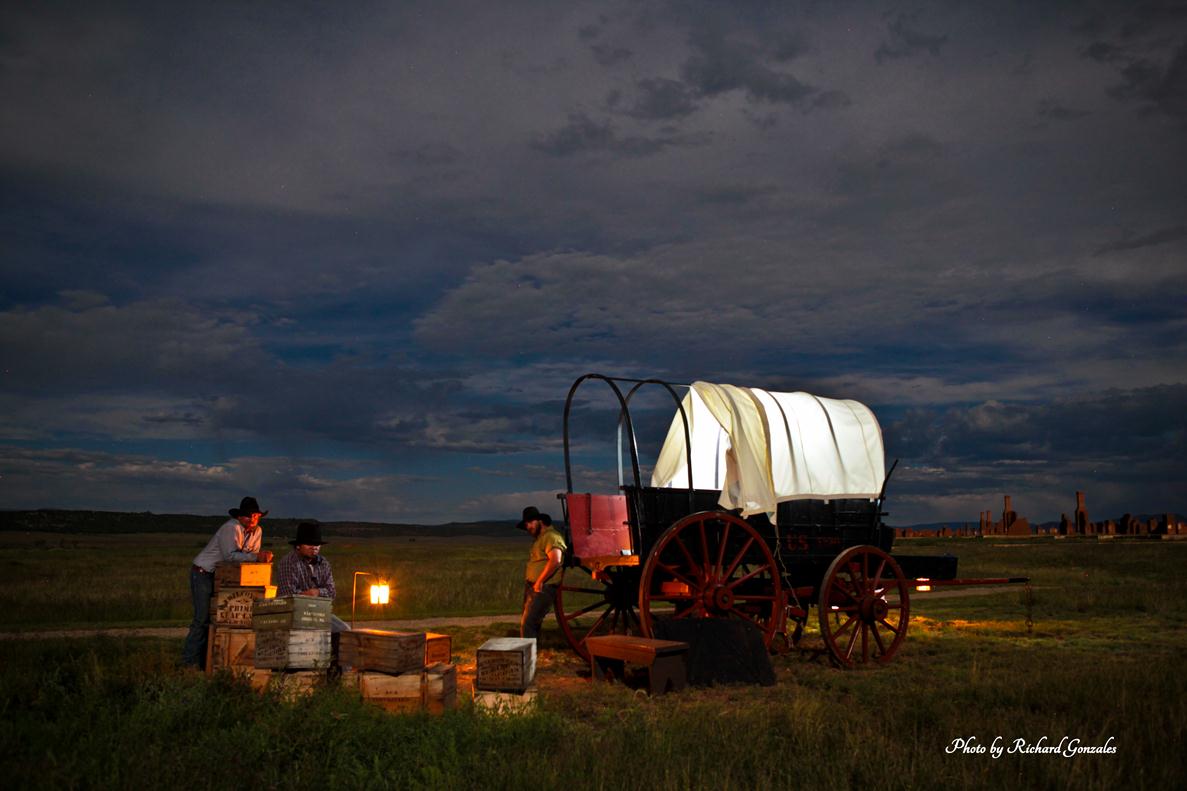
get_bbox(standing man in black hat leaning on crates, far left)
[182,498,272,669]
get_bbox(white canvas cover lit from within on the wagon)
[652,381,886,521]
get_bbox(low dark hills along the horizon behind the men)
[0,508,518,538]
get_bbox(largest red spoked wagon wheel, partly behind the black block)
[639,511,782,647]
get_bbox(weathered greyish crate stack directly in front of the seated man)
[252,595,332,690]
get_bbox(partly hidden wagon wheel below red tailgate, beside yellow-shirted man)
[556,567,641,660]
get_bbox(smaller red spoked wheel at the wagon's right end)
[818,546,910,667]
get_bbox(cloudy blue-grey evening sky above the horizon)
[0,0,1187,524]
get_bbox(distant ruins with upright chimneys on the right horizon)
[895,492,1187,538]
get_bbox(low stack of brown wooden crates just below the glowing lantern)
[338,629,457,714]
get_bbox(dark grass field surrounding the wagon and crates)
[0,536,1187,789]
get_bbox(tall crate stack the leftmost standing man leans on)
[207,563,277,675]
